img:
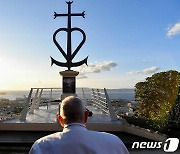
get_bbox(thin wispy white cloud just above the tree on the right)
[127,66,160,75]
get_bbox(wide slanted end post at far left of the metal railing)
[19,88,33,121]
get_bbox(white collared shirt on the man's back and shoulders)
[29,123,129,154]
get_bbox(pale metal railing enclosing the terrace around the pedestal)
[19,88,117,121]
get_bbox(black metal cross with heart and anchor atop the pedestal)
[51,1,88,70]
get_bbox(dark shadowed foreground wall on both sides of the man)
[0,131,180,154]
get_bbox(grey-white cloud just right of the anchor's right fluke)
[78,61,117,79]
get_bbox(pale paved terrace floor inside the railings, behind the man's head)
[4,104,118,124]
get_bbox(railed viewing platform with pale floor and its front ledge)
[1,88,123,131]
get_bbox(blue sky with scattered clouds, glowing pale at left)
[0,0,180,90]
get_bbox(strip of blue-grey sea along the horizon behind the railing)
[0,88,134,101]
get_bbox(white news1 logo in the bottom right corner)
[132,138,179,152]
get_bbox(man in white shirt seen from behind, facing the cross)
[29,96,129,154]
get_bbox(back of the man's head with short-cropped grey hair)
[60,96,85,124]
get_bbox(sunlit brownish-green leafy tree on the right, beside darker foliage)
[135,70,179,130]
